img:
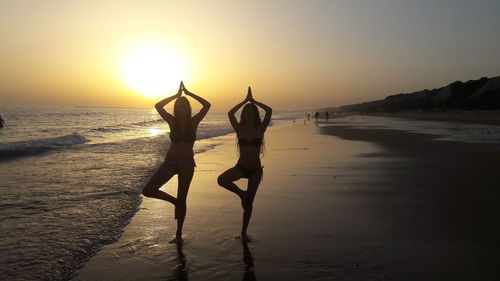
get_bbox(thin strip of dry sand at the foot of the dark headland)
[362,111,500,125]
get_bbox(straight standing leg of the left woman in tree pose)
[175,165,194,238]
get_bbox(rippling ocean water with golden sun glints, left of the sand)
[0,106,303,280]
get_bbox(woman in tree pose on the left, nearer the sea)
[142,81,210,243]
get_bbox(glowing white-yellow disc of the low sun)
[120,41,187,97]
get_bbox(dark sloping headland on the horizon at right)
[329,76,500,124]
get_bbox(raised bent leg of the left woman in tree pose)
[142,164,177,205]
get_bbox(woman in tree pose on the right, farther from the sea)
[217,87,272,241]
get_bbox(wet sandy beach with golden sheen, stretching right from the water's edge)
[73,120,500,281]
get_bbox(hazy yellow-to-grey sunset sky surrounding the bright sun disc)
[0,0,500,109]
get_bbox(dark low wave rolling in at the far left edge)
[0,133,89,160]
